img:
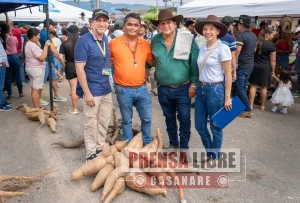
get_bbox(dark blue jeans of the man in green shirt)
[157,83,191,149]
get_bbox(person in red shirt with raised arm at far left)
[5,13,27,82]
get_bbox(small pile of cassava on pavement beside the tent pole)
[16,104,58,132]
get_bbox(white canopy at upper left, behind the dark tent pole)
[0,0,92,22]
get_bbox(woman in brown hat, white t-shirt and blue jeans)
[195,15,232,165]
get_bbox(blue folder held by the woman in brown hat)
[211,96,246,129]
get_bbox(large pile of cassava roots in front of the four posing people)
[72,129,186,203]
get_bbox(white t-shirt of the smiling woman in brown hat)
[197,40,232,82]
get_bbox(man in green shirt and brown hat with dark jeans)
[151,9,199,149]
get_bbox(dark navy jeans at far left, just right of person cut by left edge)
[5,54,23,96]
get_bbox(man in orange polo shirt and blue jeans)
[109,13,154,144]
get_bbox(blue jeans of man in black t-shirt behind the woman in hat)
[235,69,253,111]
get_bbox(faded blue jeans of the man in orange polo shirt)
[115,84,152,145]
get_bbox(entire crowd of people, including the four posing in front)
[0,9,300,164]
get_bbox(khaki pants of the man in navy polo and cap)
[83,93,113,158]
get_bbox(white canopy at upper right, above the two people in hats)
[177,0,300,18]
